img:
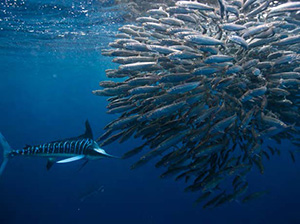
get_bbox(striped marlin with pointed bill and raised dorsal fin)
[0,121,118,176]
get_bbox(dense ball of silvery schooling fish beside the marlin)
[93,0,300,208]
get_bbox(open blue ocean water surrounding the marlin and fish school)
[0,0,300,224]
